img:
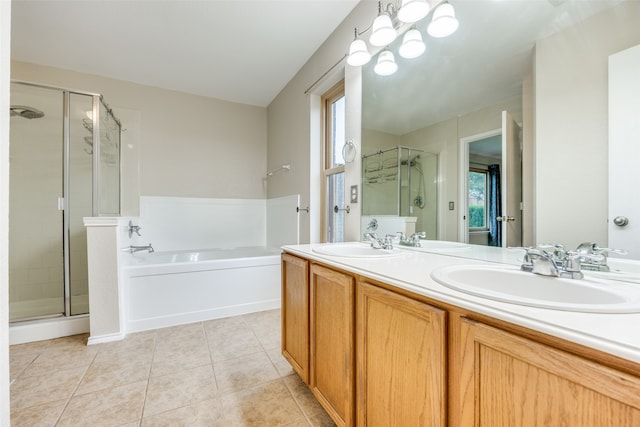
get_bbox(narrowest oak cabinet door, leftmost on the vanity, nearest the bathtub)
[282,254,309,384]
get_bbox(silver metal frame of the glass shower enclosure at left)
[9,80,122,323]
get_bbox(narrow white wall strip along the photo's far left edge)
[0,1,11,426]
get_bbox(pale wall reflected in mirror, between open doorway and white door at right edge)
[535,1,640,251]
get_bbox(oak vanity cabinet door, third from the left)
[356,282,447,427]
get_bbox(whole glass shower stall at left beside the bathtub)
[9,82,121,322]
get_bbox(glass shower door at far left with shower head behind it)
[9,84,65,321]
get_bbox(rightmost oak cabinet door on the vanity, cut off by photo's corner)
[451,318,640,427]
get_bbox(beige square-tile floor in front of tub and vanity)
[10,310,334,427]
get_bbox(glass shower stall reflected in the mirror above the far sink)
[362,146,438,239]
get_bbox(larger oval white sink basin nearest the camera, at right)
[431,265,640,313]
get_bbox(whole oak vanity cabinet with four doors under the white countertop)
[282,254,640,427]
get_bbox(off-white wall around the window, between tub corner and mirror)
[267,1,377,243]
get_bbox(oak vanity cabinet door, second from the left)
[309,264,355,426]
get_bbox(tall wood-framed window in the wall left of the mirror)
[322,82,345,242]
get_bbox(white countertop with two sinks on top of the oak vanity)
[283,244,640,363]
